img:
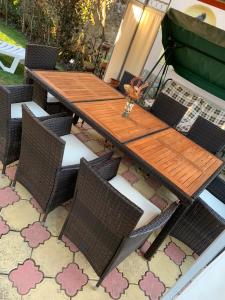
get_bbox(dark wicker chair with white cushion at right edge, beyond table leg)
[170,177,225,255]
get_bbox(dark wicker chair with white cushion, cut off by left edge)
[0,85,61,174]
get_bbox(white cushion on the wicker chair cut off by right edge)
[199,190,225,219]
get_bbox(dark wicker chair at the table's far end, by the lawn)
[24,44,69,113]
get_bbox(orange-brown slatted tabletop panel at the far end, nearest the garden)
[31,71,123,102]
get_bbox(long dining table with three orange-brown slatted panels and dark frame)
[28,70,224,259]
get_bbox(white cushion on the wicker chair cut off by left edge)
[11,101,49,119]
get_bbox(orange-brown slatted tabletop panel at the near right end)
[126,128,223,197]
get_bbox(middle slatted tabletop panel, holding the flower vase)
[74,99,168,143]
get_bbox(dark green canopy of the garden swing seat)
[162,8,225,100]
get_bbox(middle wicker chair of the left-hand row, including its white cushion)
[12,106,112,222]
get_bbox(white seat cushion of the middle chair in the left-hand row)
[61,134,98,167]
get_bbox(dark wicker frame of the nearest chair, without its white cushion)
[59,159,177,286]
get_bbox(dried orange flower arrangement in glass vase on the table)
[122,77,148,118]
